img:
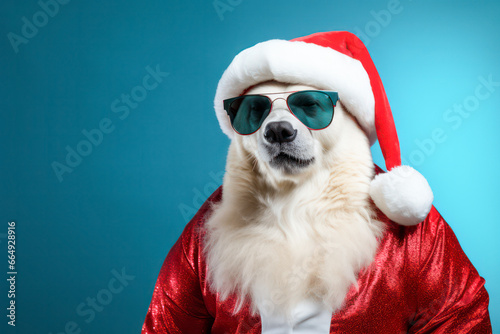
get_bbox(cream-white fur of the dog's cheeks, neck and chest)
[204,85,383,314]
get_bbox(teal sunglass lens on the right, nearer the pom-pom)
[288,91,337,130]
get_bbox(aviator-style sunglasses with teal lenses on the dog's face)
[224,90,339,135]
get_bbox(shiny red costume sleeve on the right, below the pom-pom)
[410,207,492,334]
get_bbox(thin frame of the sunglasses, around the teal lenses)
[223,89,340,136]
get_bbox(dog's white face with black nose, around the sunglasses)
[233,81,371,187]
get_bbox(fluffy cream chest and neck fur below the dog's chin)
[205,145,382,313]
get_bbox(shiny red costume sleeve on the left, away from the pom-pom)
[142,189,220,334]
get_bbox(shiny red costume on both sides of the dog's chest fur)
[142,188,492,334]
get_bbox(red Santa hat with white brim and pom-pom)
[214,31,433,226]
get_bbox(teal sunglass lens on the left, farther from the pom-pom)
[229,95,271,135]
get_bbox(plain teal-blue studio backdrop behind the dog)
[0,0,500,334]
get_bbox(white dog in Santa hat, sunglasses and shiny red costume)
[142,32,491,334]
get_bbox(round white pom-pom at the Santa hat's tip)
[370,166,434,226]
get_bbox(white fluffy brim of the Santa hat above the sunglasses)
[214,39,377,144]
